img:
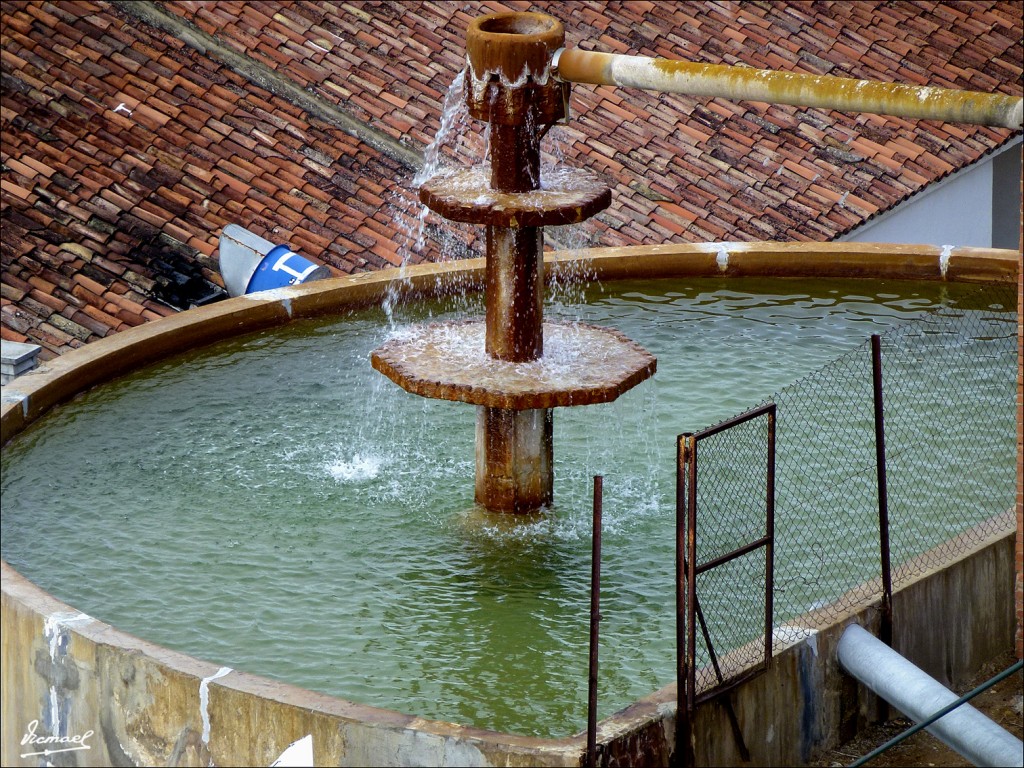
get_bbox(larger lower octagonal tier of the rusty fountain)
[370,319,657,411]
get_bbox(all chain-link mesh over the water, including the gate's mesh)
[679,285,1018,689]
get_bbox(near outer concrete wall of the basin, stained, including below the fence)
[0,524,1015,766]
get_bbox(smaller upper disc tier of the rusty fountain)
[420,167,611,227]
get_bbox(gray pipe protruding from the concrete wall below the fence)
[839,624,1024,766]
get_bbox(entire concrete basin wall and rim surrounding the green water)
[0,244,1019,766]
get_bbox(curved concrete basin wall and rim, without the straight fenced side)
[0,244,1019,765]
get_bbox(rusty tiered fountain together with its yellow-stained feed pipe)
[372,13,1022,513]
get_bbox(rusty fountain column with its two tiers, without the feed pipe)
[371,13,656,513]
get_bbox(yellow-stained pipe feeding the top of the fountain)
[552,48,1022,129]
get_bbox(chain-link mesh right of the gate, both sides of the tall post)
[772,285,1017,624]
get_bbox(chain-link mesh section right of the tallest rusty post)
[882,287,1018,581]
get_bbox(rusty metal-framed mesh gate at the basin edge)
[679,404,775,702]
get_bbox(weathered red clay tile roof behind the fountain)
[0,0,1024,358]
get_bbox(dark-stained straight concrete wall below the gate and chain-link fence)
[694,516,1016,765]
